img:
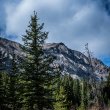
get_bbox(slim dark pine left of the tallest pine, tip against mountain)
[6,52,19,110]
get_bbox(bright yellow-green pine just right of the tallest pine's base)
[54,75,71,110]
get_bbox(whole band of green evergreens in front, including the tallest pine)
[0,12,110,110]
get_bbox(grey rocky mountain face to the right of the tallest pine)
[44,43,108,79]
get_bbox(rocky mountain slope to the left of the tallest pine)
[0,38,25,70]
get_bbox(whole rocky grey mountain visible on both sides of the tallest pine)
[0,38,108,79]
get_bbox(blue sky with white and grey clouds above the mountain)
[0,0,110,65]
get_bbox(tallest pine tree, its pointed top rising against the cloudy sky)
[22,12,59,110]
